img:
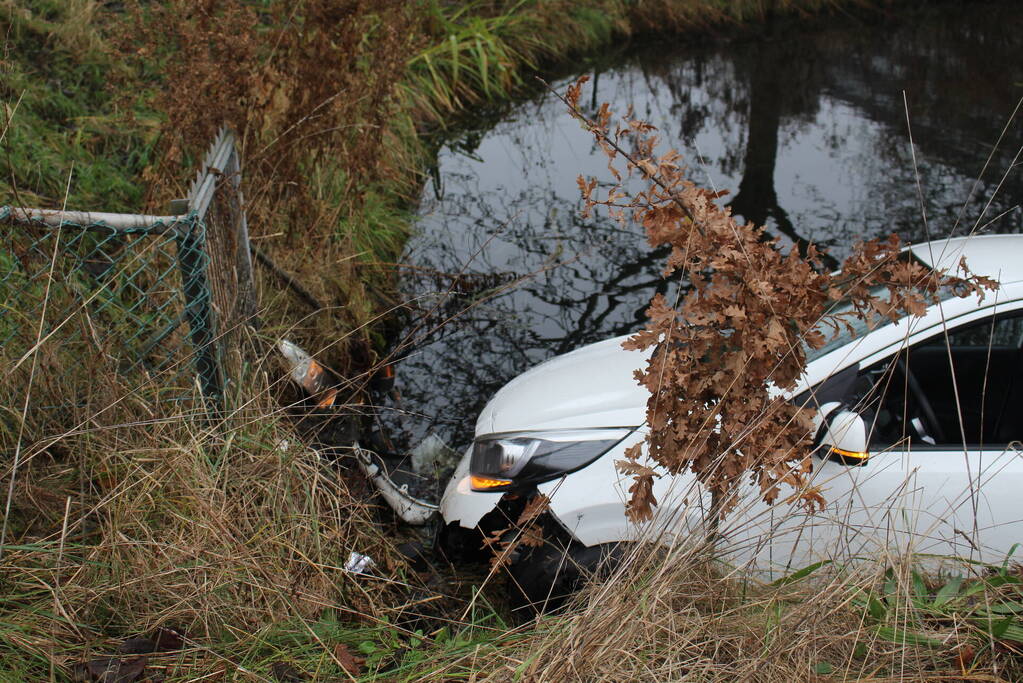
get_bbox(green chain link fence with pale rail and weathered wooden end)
[0,130,256,417]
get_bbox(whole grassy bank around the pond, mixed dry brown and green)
[0,0,965,681]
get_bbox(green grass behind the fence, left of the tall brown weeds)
[0,0,162,211]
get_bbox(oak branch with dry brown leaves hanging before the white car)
[563,76,996,521]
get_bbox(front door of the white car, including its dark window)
[724,302,1023,578]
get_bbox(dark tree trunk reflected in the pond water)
[728,43,838,268]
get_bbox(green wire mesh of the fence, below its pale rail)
[0,207,221,408]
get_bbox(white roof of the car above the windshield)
[908,234,1023,284]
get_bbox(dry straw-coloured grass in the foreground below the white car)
[398,548,1023,683]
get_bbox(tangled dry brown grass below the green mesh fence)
[0,331,415,680]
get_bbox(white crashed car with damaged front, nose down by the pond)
[440,235,1023,599]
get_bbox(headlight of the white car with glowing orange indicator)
[469,428,632,491]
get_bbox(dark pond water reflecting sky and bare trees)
[380,2,1023,462]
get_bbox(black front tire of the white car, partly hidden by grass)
[508,542,622,612]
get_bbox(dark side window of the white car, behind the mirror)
[856,311,1023,448]
